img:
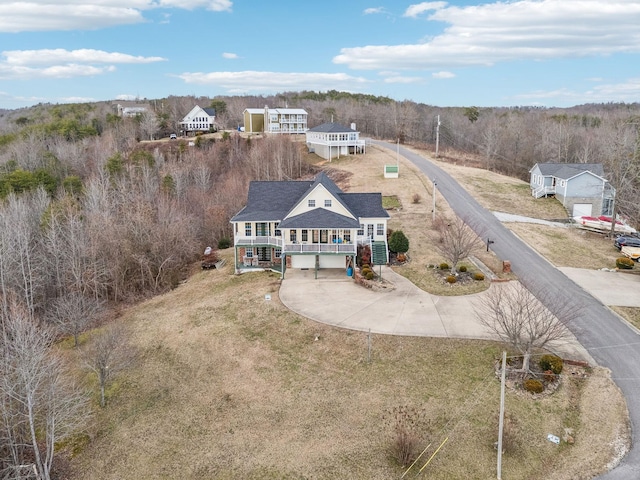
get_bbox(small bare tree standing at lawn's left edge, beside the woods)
[83,324,134,407]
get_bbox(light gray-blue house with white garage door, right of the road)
[529,163,615,217]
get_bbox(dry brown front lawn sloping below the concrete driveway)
[67,252,624,480]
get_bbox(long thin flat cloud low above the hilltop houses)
[178,71,368,92]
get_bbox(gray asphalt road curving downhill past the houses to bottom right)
[373,141,640,480]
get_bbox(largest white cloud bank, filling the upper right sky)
[333,0,640,70]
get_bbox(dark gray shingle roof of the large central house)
[231,172,389,228]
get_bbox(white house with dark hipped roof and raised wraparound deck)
[306,122,365,161]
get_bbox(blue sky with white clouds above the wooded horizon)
[0,0,640,109]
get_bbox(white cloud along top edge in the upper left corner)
[0,0,233,33]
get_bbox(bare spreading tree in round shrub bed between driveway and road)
[477,282,580,372]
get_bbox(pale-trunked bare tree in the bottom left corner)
[0,300,88,480]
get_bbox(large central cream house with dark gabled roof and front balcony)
[231,172,389,277]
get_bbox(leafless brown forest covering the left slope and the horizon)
[0,91,640,478]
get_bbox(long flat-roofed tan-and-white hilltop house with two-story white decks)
[242,105,308,134]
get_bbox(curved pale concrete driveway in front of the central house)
[279,267,593,362]
